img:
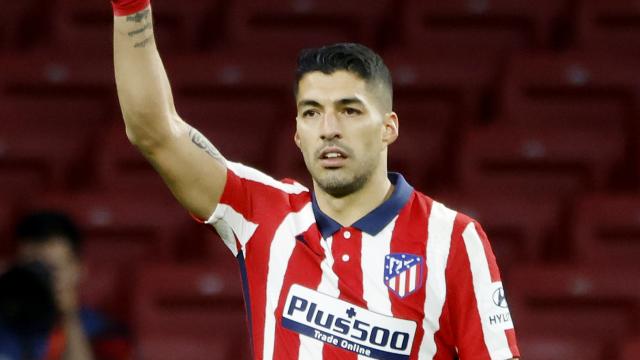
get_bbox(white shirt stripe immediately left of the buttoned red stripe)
[298,237,340,360]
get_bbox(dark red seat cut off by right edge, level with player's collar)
[573,194,640,266]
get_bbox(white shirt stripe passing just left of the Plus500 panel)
[262,203,315,360]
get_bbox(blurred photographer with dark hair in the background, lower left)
[0,211,131,360]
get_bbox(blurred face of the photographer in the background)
[18,237,82,308]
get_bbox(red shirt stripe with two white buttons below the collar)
[322,227,367,360]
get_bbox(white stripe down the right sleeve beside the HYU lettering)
[462,223,513,359]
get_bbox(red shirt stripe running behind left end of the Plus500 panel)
[273,224,325,359]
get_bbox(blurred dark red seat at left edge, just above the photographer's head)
[0,96,103,195]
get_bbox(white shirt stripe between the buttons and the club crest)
[358,216,398,360]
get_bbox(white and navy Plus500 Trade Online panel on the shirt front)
[282,285,416,360]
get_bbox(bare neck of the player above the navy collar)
[314,169,394,226]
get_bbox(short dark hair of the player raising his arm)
[293,43,393,107]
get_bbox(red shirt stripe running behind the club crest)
[388,193,431,359]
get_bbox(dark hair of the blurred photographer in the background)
[15,210,82,257]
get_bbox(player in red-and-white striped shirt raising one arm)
[113,0,519,360]
